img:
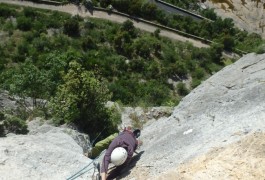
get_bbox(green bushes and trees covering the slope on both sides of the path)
[0,0,263,137]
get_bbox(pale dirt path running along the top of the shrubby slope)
[0,0,209,48]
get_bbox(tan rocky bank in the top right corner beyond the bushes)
[204,0,265,38]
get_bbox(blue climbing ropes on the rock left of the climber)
[66,150,106,180]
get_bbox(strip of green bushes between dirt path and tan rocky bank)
[85,0,263,52]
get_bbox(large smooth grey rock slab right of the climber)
[128,54,265,179]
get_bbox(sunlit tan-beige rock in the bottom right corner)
[154,133,265,180]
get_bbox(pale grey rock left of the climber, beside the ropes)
[0,121,93,180]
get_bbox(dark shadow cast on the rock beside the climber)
[107,151,144,180]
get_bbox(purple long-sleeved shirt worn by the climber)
[101,130,138,173]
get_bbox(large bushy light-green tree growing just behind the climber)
[51,61,118,136]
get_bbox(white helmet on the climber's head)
[110,147,127,166]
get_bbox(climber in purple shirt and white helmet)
[101,126,142,180]
